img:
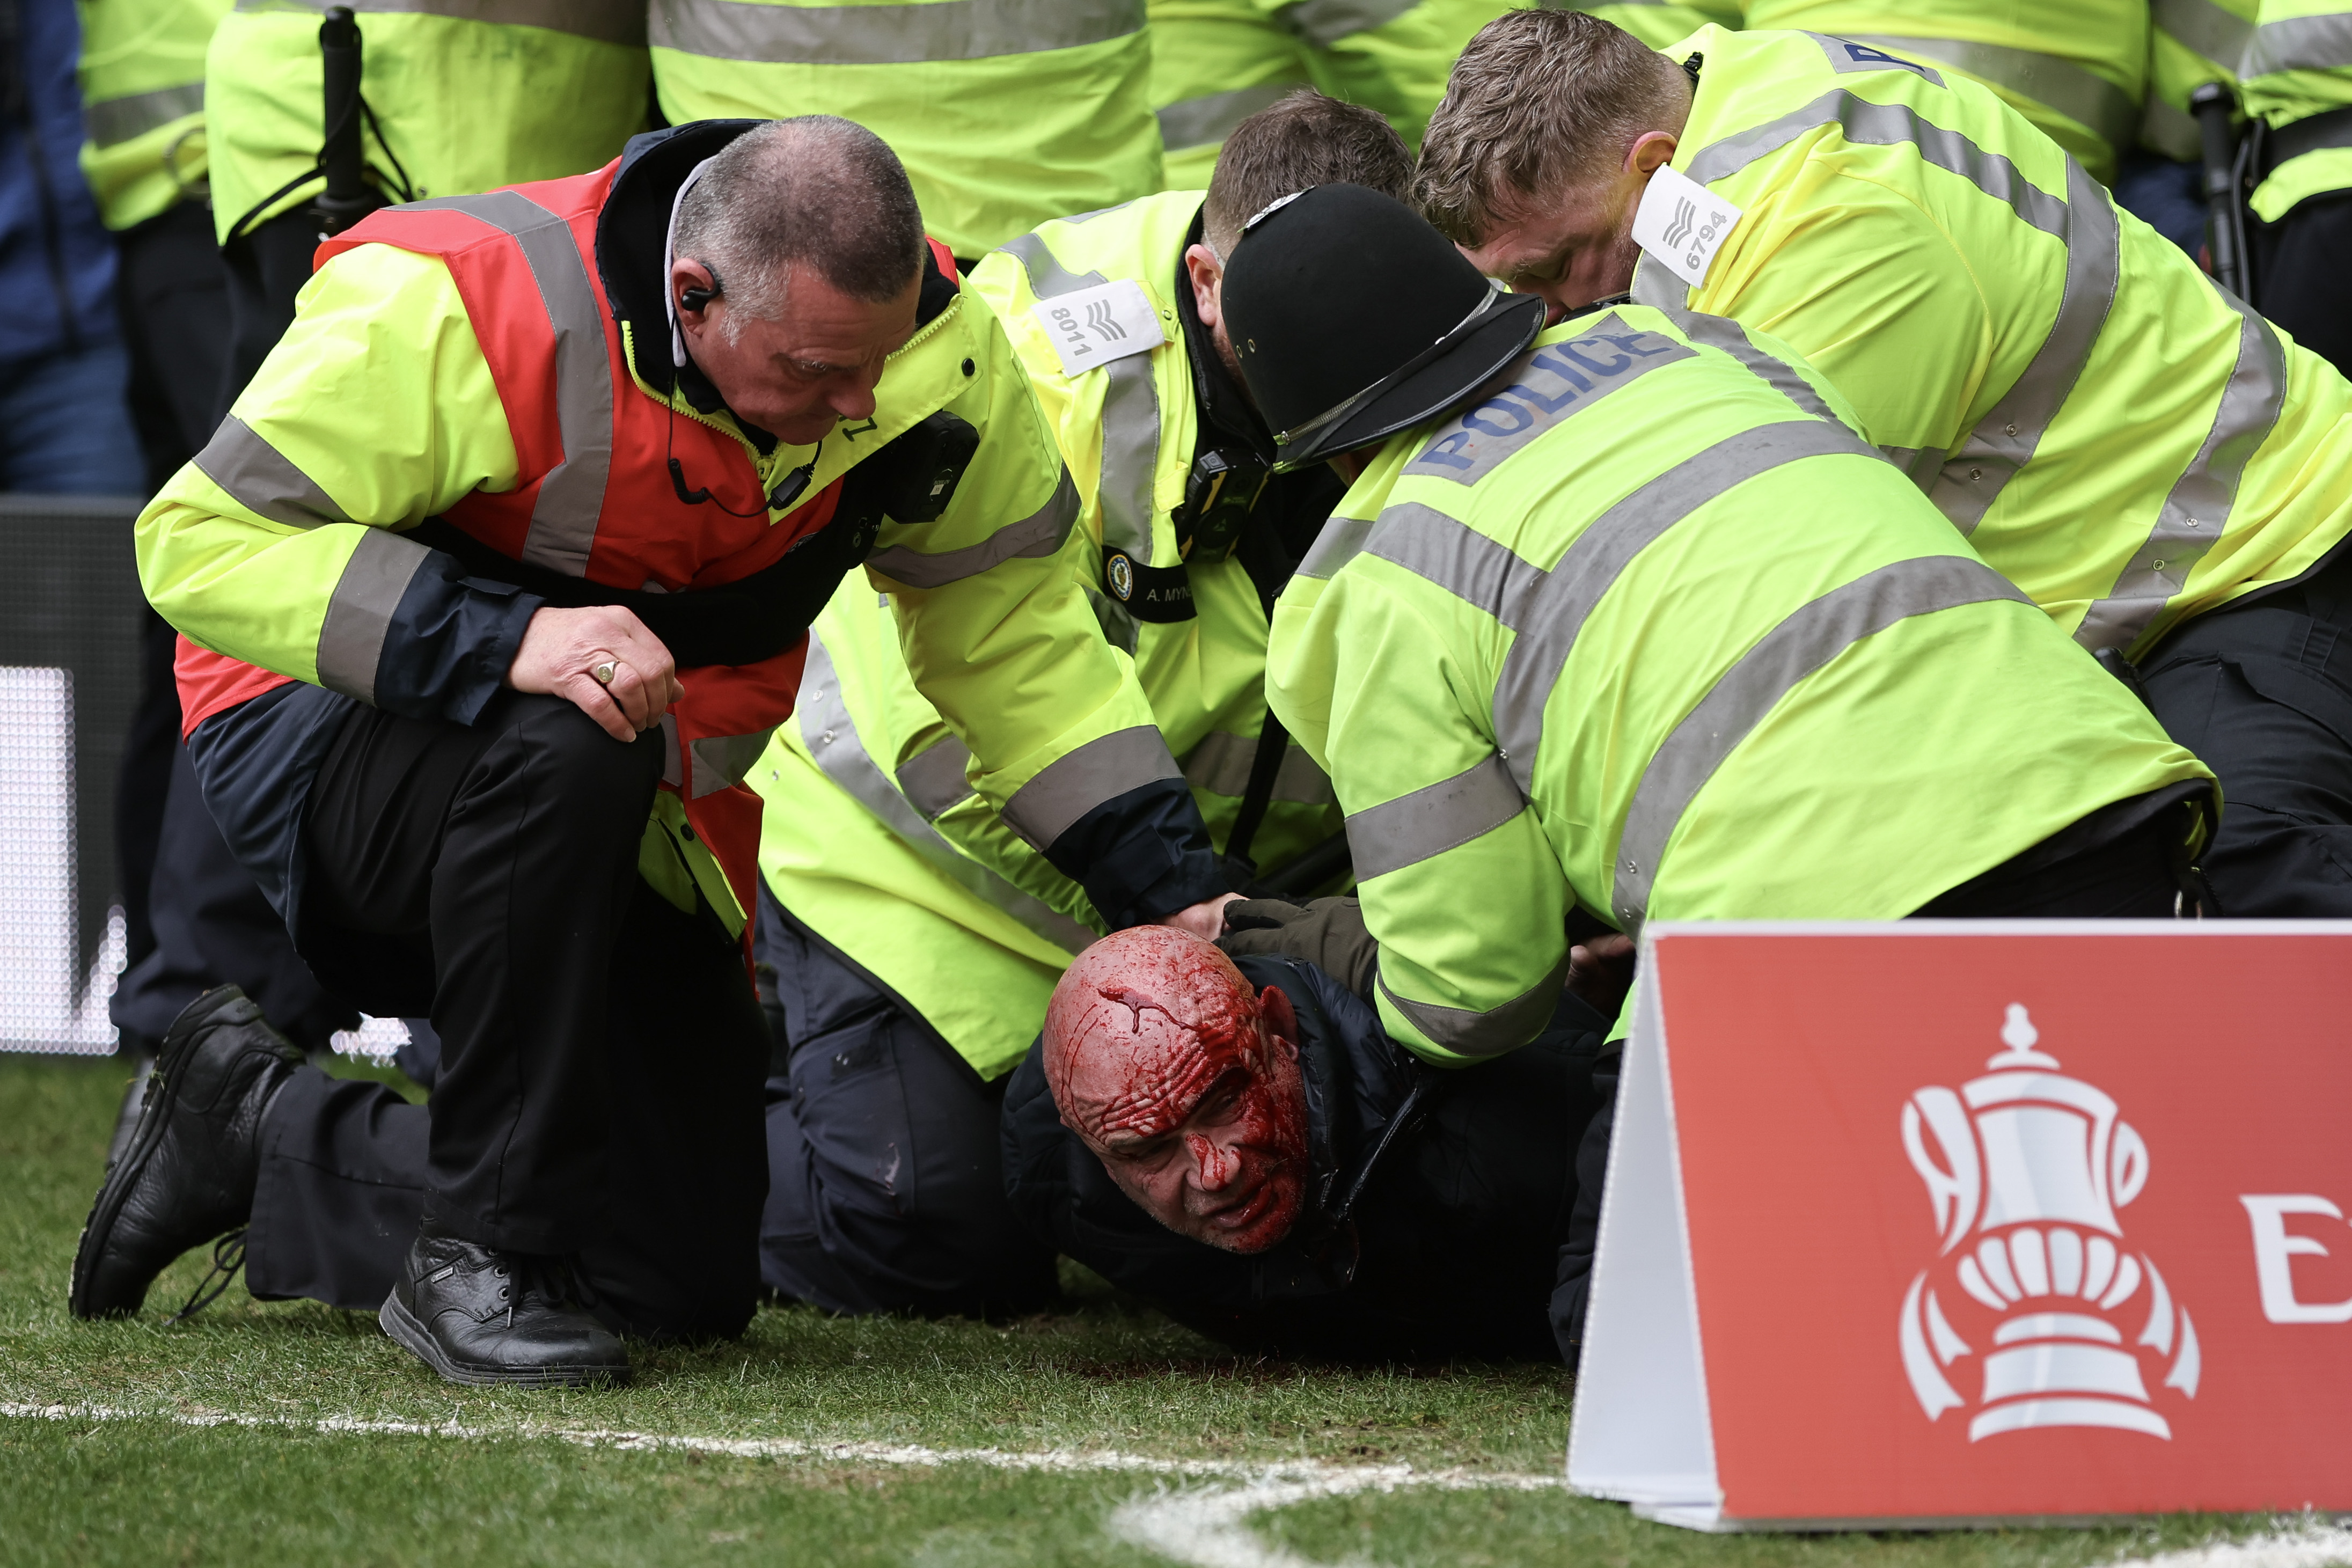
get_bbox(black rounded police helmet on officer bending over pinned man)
[1223,186,1543,470]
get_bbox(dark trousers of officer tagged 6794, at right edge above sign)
[2141,550,2352,919]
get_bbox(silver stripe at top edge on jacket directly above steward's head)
[647,0,1143,66]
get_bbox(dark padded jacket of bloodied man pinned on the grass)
[1005,955,1604,1361]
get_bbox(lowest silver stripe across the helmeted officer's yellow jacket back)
[1611,555,2032,936]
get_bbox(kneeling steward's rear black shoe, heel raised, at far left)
[68,985,303,1316]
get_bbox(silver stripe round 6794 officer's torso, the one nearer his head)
[1926,158,2124,533]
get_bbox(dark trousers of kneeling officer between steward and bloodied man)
[760,889,1056,1316]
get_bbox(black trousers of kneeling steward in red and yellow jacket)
[247,691,767,1338]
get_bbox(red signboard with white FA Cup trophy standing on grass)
[1569,921,2352,1530]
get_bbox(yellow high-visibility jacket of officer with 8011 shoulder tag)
[753,193,1340,1076]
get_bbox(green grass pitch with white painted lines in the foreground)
[0,1056,2295,1568]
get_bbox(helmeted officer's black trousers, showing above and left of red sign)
[1552,816,2192,1366]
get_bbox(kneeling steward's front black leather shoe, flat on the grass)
[376,1232,628,1387]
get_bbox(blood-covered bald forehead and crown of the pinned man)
[1044,926,1261,1145]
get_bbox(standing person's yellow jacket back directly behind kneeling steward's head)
[649,0,1160,259]
